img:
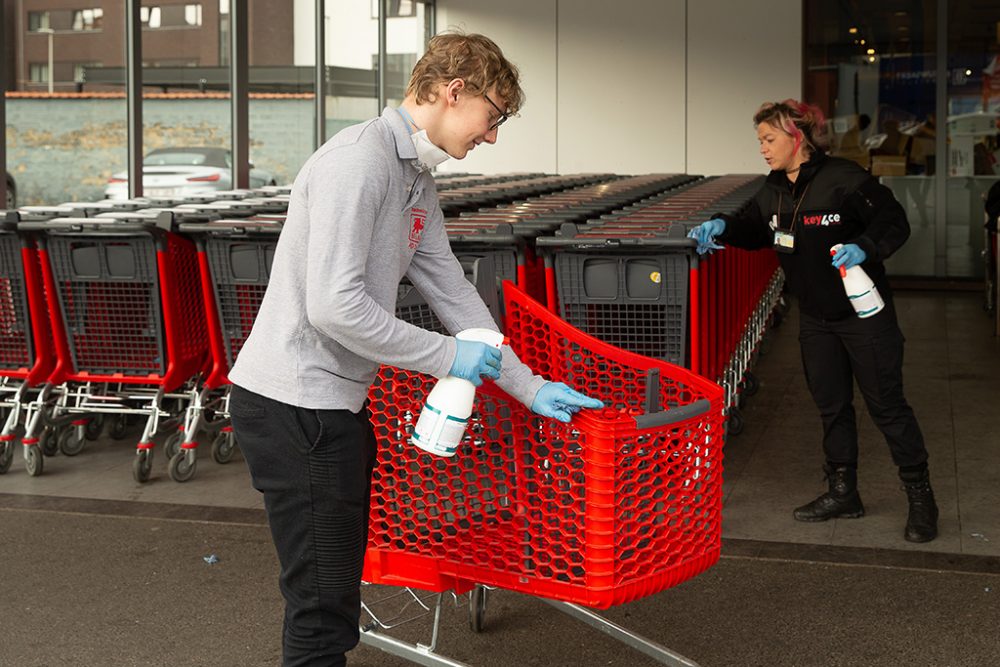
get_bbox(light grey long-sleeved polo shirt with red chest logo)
[229,108,545,412]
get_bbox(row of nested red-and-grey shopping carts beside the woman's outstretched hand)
[536,174,783,434]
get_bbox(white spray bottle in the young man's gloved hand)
[410,329,508,456]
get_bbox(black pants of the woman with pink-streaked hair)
[799,303,927,468]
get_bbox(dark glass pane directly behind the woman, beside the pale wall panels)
[805,0,937,275]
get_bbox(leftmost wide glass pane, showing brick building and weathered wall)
[5,0,127,206]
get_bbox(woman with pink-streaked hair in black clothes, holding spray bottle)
[689,100,938,542]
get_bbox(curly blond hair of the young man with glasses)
[406,31,524,116]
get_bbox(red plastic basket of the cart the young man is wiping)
[365,282,723,608]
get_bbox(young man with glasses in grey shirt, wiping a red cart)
[229,34,601,667]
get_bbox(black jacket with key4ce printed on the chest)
[717,153,910,320]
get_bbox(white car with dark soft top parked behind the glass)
[104,146,276,199]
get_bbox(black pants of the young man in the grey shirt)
[230,386,375,667]
